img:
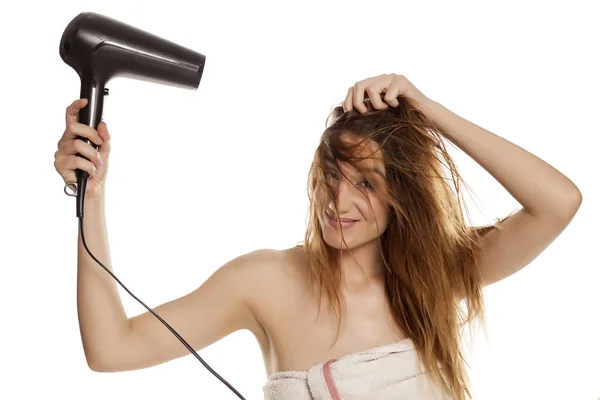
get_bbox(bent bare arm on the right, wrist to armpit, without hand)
[423,102,582,285]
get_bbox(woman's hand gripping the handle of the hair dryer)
[54,99,110,198]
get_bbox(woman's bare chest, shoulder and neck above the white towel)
[253,244,406,376]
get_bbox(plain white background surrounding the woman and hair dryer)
[0,0,600,400]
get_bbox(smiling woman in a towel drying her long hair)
[55,74,582,399]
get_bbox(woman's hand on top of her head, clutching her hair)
[343,74,435,115]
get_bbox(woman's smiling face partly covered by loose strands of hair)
[319,136,388,249]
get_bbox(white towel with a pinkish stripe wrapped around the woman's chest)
[263,338,450,400]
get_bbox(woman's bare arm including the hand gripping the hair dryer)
[54,99,270,372]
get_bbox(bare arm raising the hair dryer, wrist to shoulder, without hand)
[77,198,268,372]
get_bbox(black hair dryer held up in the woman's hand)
[60,12,205,218]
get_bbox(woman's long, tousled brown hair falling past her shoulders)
[302,96,507,400]
